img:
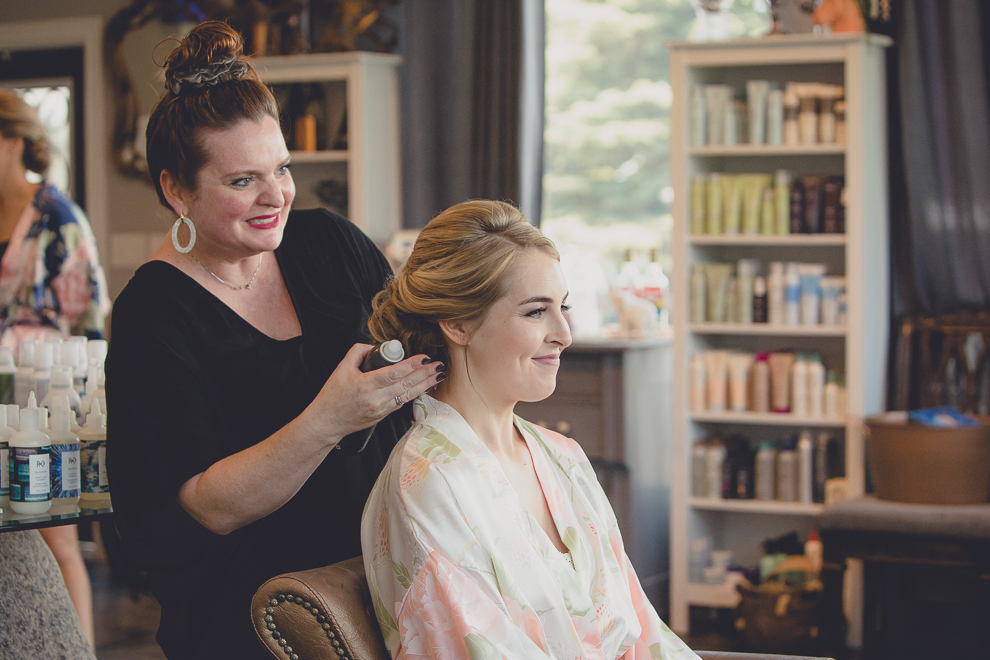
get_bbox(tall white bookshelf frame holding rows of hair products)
[670,35,890,643]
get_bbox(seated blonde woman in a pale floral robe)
[361,201,697,660]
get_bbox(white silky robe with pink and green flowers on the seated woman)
[361,396,697,660]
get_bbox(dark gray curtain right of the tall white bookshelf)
[891,0,990,318]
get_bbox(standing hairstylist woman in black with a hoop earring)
[107,22,442,660]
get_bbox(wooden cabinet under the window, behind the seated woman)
[516,339,672,616]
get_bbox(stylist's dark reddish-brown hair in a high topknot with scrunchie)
[145,21,278,208]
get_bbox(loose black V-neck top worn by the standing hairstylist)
[106,210,411,660]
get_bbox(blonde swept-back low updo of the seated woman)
[368,200,560,365]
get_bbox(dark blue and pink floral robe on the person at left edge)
[0,184,110,351]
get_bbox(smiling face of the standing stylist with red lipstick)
[185,115,296,259]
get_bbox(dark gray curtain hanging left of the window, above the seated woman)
[402,0,543,227]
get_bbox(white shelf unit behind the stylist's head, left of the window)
[255,52,402,245]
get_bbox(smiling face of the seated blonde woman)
[466,249,571,407]
